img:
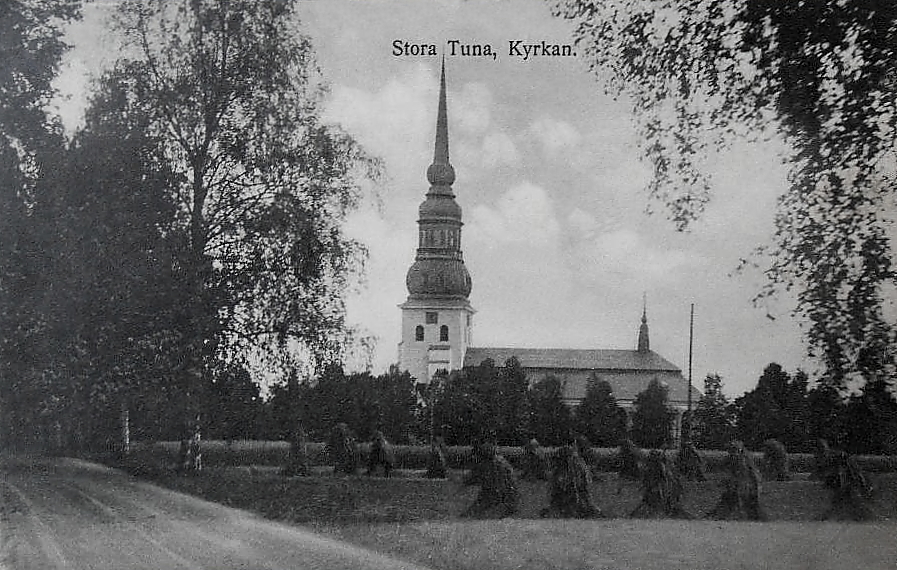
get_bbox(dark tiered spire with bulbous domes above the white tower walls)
[405,59,471,299]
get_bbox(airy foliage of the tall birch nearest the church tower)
[106,0,376,400]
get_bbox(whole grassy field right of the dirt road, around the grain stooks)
[110,444,897,570]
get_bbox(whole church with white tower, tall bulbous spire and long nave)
[399,64,700,439]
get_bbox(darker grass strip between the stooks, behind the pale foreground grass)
[124,467,897,526]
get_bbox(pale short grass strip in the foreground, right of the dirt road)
[326,519,897,570]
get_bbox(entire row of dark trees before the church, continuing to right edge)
[22,346,897,454]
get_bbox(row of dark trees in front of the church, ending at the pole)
[72,359,672,447]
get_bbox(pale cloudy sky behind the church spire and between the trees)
[58,0,816,396]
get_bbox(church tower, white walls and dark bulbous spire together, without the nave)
[399,59,475,383]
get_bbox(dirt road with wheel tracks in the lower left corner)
[0,458,421,570]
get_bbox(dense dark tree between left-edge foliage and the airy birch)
[50,80,187,439]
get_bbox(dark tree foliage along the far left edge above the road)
[0,0,81,448]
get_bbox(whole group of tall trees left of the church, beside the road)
[0,0,379,450]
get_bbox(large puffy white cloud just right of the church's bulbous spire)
[469,182,560,246]
